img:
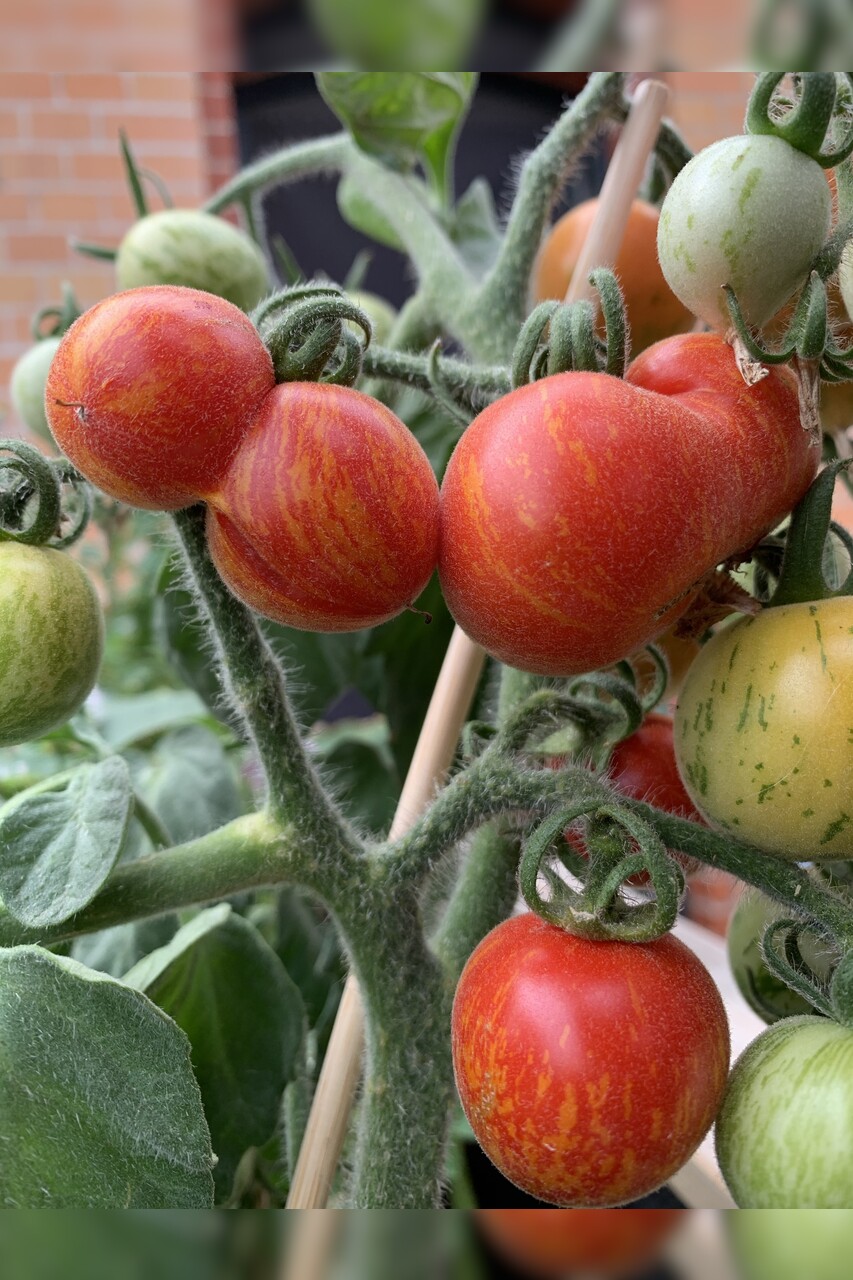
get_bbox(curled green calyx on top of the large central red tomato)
[511,268,629,388]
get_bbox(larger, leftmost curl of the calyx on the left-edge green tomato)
[0,440,61,547]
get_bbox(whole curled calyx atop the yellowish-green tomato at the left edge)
[0,439,91,548]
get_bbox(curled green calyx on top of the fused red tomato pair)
[252,283,373,387]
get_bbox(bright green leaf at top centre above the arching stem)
[316,72,476,195]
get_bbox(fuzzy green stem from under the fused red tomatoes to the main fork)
[174,506,361,867]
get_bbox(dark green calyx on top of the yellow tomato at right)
[767,458,853,608]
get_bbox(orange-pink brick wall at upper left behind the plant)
[0,72,237,425]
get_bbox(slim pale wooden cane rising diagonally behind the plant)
[287,79,669,1218]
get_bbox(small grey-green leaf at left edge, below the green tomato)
[0,755,133,928]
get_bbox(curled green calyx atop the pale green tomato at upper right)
[747,72,853,169]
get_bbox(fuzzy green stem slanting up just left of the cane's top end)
[466,72,625,361]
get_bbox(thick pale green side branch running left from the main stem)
[0,813,289,947]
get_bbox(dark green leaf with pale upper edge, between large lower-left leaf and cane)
[124,904,305,1201]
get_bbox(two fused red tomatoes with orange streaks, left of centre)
[46,285,438,631]
